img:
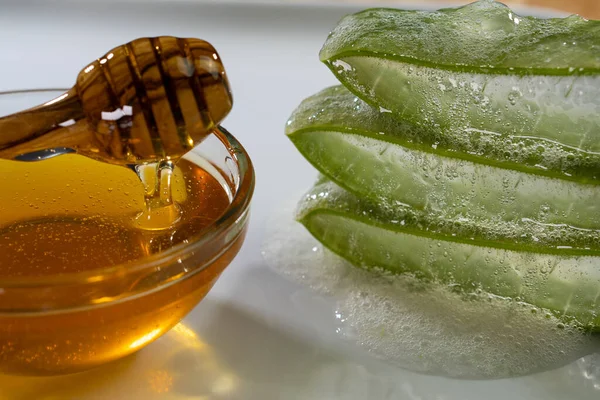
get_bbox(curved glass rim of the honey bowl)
[0,88,255,289]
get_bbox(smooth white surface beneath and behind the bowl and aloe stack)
[0,1,600,400]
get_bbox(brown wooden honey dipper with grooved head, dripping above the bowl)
[0,36,233,165]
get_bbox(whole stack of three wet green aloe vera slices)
[286,0,600,333]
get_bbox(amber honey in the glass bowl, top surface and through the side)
[0,155,243,374]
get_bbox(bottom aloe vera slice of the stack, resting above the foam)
[297,181,600,332]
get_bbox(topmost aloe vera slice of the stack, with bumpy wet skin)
[320,1,600,153]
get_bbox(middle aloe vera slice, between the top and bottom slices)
[286,87,600,228]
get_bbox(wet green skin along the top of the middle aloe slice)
[286,86,600,184]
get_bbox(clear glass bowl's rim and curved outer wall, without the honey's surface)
[0,89,254,375]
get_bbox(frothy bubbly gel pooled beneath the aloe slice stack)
[263,200,600,379]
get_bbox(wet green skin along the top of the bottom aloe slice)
[303,174,600,256]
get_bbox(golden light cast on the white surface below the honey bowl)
[0,323,240,400]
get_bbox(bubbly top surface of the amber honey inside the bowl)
[0,154,230,279]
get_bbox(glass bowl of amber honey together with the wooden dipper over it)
[0,36,254,375]
